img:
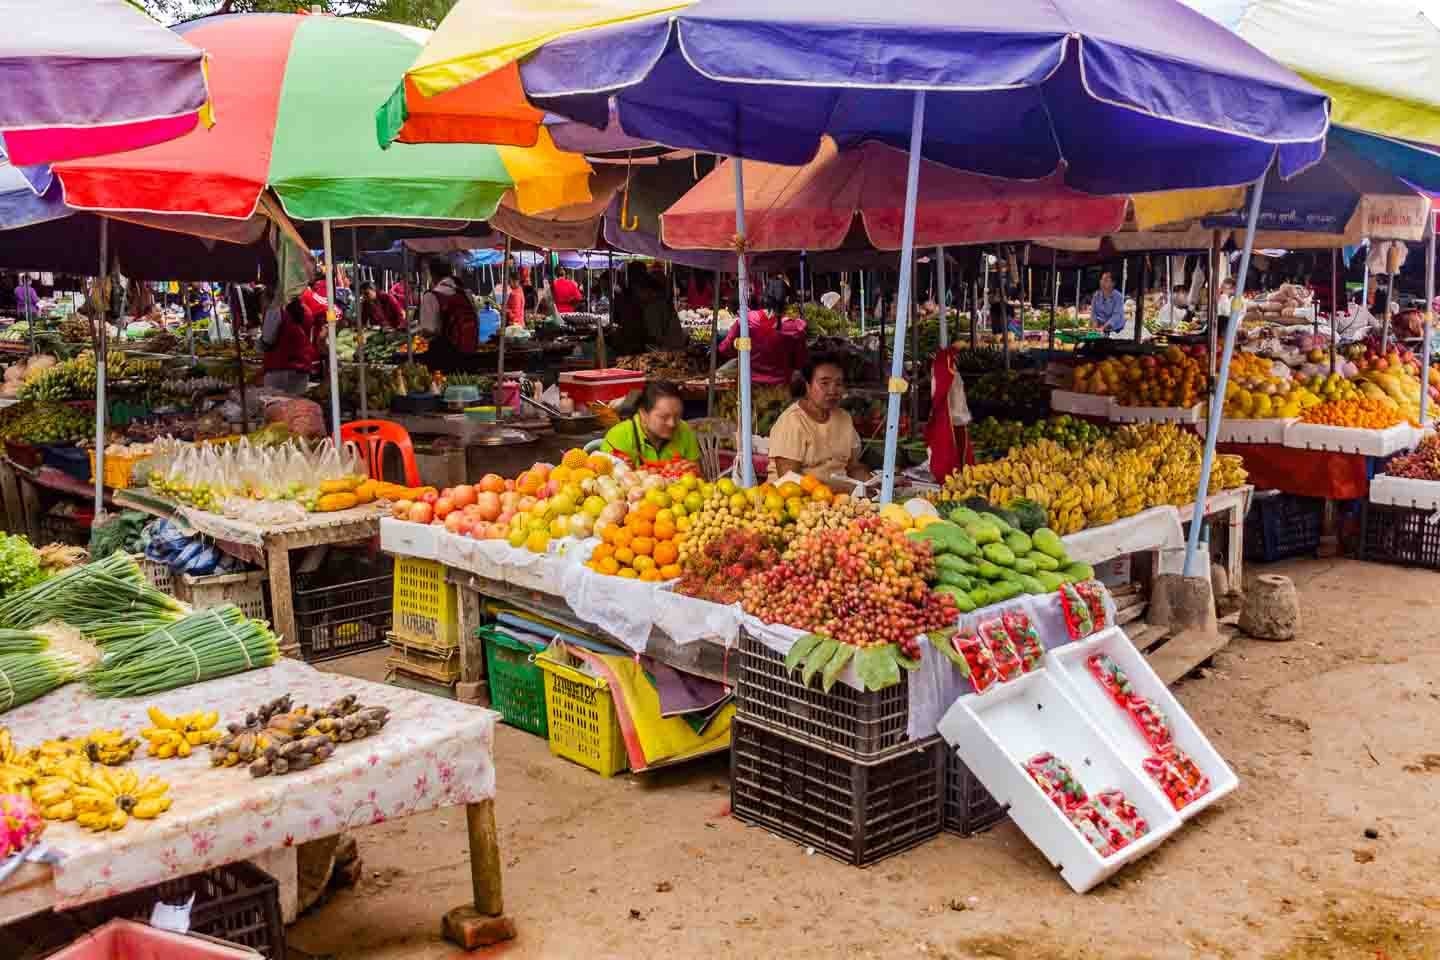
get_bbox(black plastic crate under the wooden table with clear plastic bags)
[295,558,395,662]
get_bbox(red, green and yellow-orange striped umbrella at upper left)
[55,13,590,220]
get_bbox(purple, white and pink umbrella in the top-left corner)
[0,0,209,164]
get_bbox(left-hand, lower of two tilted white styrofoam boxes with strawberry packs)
[939,669,1181,894]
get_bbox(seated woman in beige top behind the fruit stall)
[769,354,870,482]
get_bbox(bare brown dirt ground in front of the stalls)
[289,561,1440,960]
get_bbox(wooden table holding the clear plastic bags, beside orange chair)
[114,488,386,656]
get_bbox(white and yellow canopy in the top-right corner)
[1184,0,1440,142]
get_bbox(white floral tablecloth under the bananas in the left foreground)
[0,659,500,924]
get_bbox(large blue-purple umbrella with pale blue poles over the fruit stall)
[509,0,1329,499]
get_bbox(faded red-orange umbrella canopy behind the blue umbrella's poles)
[661,140,1125,252]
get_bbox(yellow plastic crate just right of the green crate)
[536,648,629,777]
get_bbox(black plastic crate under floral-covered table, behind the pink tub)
[0,861,285,960]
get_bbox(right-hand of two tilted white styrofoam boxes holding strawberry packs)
[1045,626,1240,820]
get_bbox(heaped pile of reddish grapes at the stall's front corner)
[740,517,958,659]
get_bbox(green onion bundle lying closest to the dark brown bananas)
[85,603,279,697]
